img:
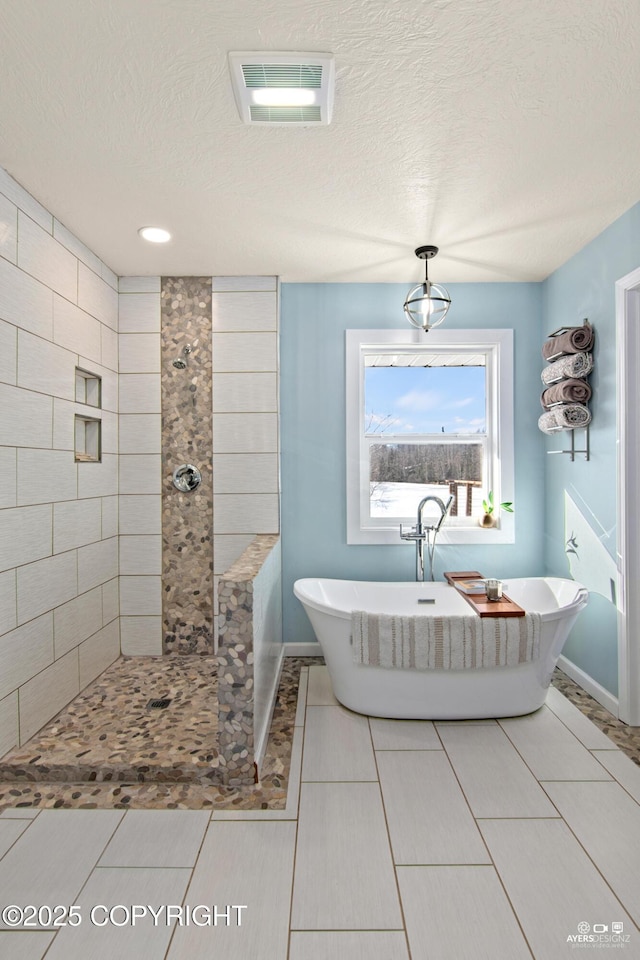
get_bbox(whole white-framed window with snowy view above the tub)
[347,330,514,544]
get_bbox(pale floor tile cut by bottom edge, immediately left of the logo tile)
[398,867,531,960]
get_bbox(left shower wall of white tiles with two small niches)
[0,169,119,748]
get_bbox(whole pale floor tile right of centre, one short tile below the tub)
[376,750,490,864]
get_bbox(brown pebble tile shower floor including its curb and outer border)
[0,656,308,809]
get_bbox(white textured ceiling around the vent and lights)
[0,0,640,282]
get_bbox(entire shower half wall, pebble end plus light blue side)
[218,534,284,786]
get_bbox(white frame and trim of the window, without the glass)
[346,329,515,546]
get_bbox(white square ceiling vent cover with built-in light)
[229,51,335,127]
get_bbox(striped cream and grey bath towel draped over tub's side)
[351,610,541,670]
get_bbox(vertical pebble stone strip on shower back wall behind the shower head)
[161,277,215,656]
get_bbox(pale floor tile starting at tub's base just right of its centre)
[438,724,558,817]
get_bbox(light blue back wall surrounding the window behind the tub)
[280,282,545,642]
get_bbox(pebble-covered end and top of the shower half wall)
[218,534,279,786]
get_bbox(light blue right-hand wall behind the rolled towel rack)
[542,204,640,694]
